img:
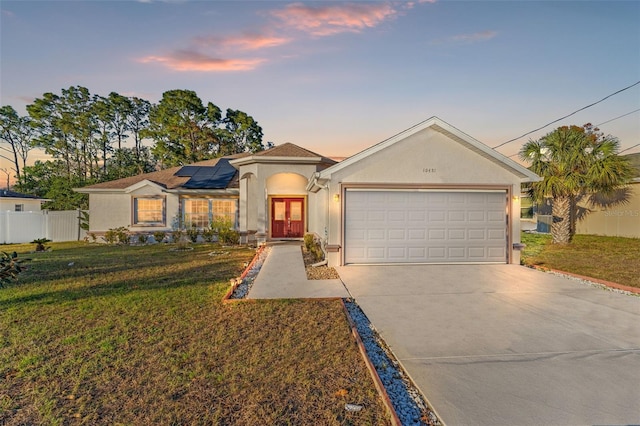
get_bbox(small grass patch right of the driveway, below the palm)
[522,233,640,288]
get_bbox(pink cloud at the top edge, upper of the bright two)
[271,3,398,36]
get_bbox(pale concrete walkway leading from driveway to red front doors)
[247,242,350,299]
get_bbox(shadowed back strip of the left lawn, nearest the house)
[0,248,255,308]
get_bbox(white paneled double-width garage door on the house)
[345,189,507,263]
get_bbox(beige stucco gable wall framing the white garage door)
[318,128,521,265]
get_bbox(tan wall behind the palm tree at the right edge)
[576,182,640,238]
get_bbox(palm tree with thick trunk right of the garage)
[519,124,632,244]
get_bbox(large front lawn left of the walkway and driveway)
[0,243,389,425]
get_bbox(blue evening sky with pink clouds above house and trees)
[0,0,640,171]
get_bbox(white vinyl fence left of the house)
[0,210,86,244]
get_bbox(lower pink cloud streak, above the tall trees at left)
[139,50,264,72]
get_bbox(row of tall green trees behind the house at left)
[0,86,272,210]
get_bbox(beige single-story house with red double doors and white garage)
[78,117,540,265]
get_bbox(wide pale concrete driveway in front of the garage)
[337,265,640,425]
